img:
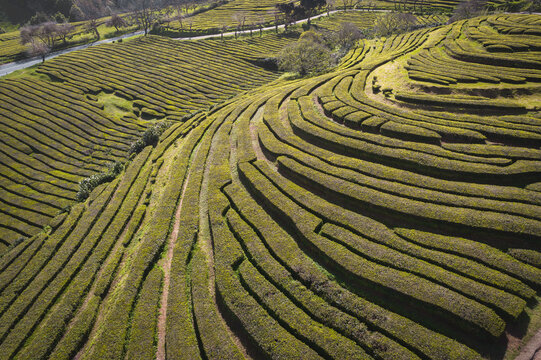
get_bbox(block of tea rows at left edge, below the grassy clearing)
[0,80,148,248]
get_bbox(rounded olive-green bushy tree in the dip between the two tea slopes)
[277,36,331,76]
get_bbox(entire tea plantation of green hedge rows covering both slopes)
[0,7,541,360]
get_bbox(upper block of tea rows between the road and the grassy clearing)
[38,34,295,118]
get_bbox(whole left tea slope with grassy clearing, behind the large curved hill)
[0,32,292,254]
